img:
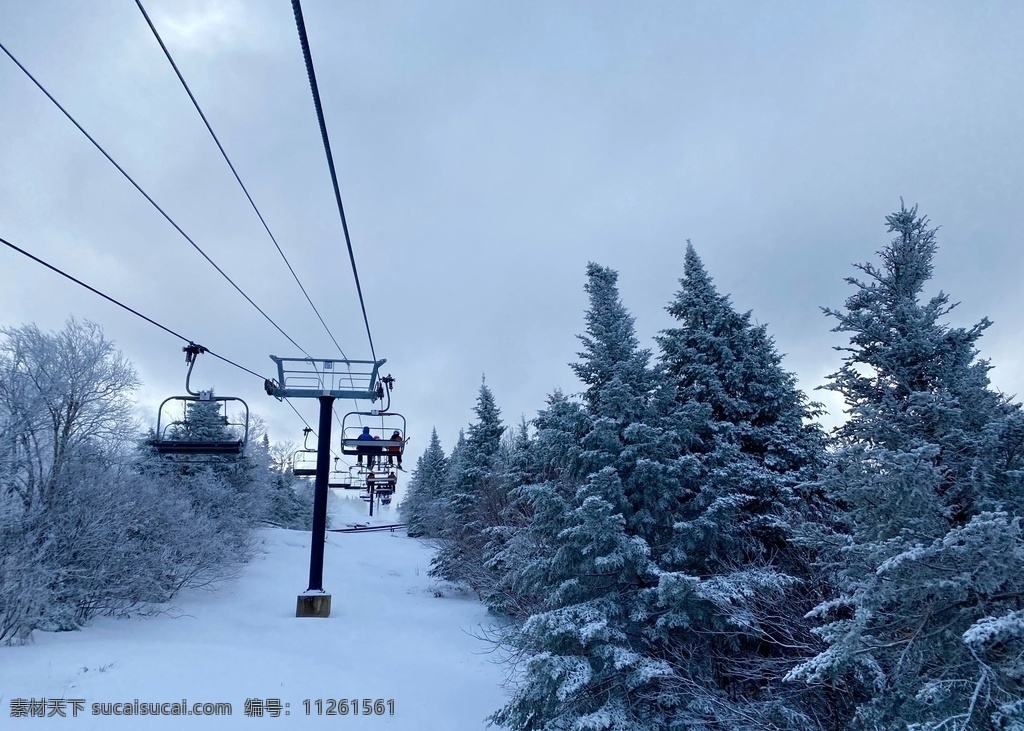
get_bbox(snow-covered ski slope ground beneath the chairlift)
[0,497,506,731]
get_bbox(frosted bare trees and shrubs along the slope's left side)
[0,318,312,643]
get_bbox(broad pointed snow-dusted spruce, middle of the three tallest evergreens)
[650,242,823,729]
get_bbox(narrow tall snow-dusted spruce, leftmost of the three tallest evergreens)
[493,263,667,730]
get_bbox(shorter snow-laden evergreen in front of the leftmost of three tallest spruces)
[493,467,667,731]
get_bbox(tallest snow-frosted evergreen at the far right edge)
[792,206,1024,731]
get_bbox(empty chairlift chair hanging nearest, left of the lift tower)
[150,343,249,455]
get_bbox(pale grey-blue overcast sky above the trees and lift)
[0,0,1024,455]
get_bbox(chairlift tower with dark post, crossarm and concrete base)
[264,355,393,617]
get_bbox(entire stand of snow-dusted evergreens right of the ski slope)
[402,206,1024,731]
